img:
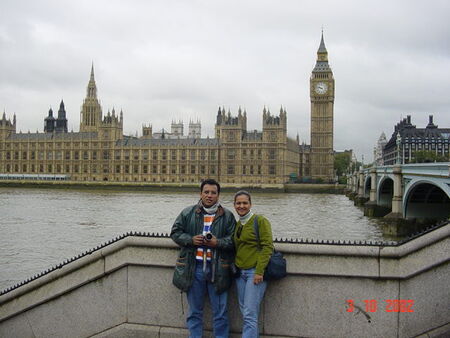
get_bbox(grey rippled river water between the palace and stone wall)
[0,188,387,290]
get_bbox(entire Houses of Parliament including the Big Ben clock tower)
[0,34,334,186]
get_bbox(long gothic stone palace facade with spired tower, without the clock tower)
[0,69,299,185]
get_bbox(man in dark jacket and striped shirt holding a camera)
[170,179,236,338]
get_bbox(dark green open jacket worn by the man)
[170,205,236,293]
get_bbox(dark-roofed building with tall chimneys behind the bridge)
[383,115,450,165]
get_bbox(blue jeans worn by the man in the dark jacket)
[186,262,230,338]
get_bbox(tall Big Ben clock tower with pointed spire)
[310,32,334,182]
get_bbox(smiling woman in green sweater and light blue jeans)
[234,190,273,338]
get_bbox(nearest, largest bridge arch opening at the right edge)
[403,179,450,219]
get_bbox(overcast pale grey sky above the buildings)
[0,0,450,163]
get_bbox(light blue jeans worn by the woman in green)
[236,268,267,338]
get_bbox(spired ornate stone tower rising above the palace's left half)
[80,65,102,132]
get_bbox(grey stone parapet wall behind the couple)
[0,224,450,338]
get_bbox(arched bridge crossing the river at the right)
[347,162,450,231]
